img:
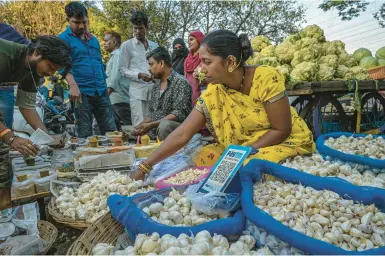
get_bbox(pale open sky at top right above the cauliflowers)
[298,0,385,55]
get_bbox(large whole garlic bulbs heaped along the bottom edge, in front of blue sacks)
[93,230,273,255]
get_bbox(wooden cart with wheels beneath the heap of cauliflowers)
[287,80,385,137]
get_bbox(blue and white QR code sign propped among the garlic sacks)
[197,145,252,193]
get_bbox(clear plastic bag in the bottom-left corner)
[0,235,47,255]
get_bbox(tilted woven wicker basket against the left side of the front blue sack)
[67,213,124,255]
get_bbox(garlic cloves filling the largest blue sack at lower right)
[253,181,385,251]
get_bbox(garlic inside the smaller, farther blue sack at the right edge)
[325,134,385,159]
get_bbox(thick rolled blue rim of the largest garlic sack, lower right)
[240,159,385,255]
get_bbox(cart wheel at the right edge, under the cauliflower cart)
[354,92,385,132]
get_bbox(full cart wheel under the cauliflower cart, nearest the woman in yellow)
[300,96,348,137]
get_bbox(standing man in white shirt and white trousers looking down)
[120,11,158,126]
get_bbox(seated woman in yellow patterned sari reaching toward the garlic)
[133,30,315,179]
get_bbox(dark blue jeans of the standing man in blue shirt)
[75,90,116,138]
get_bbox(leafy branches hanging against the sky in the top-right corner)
[319,0,385,27]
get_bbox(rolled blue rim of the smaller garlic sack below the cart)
[316,132,385,169]
